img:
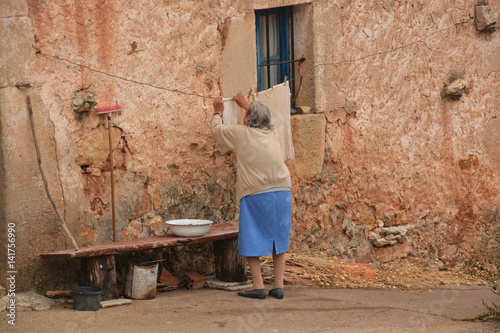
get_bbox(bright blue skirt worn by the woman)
[238,191,292,257]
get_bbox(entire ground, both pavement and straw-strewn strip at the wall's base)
[0,255,500,333]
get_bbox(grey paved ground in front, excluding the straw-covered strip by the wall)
[0,286,500,333]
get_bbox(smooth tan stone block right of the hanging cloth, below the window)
[289,114,326,178]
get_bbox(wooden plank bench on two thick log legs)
[40,222,247,297]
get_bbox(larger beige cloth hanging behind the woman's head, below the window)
[253,80,295,160]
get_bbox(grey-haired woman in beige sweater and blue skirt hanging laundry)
[210,92,292,299]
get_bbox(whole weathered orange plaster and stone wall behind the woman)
[0,0,500,289]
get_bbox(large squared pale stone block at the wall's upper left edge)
[0,16,35,88]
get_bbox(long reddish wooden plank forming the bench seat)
[40,221,239,259]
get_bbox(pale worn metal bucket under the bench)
[125,260,158,299]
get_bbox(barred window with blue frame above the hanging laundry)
[255,7,292,91]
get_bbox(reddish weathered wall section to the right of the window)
[295,1,500,266]
